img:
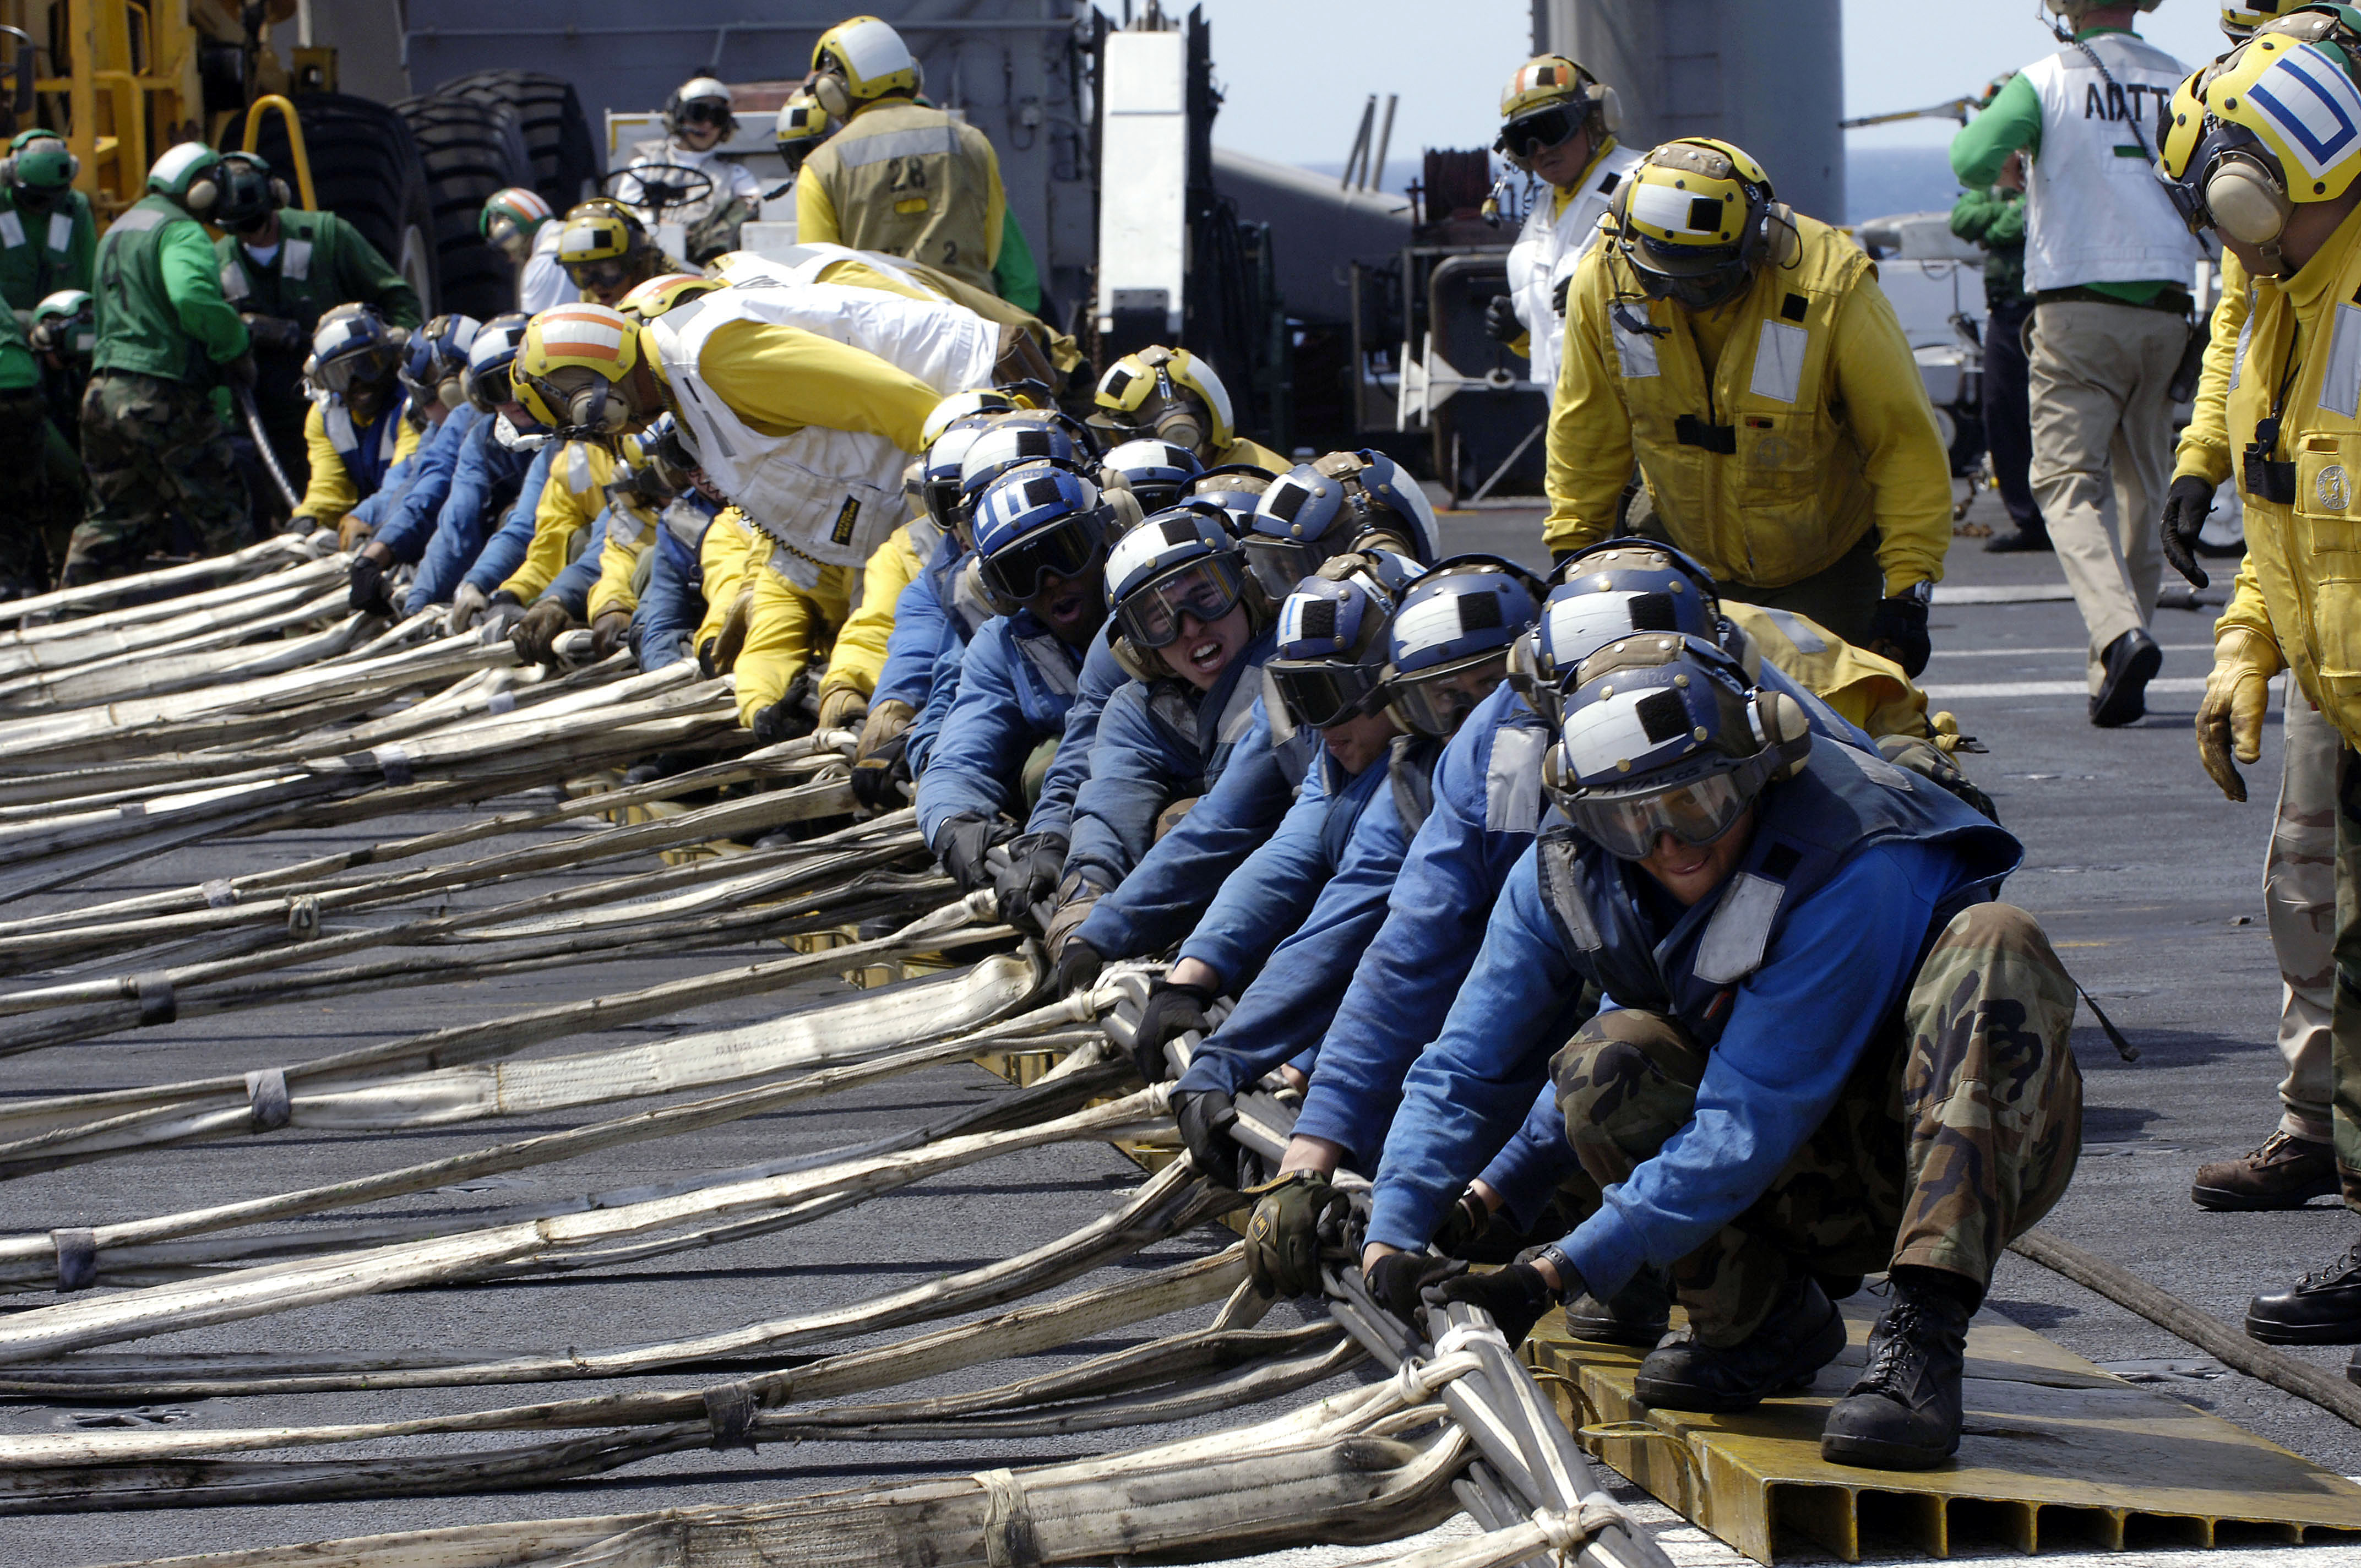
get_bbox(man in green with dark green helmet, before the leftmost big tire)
[208,154,425,513]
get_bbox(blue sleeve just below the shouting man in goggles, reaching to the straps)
[1067,696,1294,959]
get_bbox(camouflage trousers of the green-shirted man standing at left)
[66,371,255,581]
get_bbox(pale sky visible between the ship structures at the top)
[1190,0,2222,175]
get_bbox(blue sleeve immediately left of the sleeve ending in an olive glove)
[1180,784,1407,1093]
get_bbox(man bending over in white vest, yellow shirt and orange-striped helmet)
[517,298,942,744]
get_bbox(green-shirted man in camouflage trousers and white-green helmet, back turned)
[59,141,255,588]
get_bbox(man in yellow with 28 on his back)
[796,17,1008,293]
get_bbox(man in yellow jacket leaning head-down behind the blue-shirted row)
[1544,137,1950,676]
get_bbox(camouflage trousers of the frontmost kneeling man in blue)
[1551,905,2082,1346]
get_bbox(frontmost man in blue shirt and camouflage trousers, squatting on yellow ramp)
[1362,633,2082,1469]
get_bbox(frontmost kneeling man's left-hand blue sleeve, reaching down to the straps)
[1359,846,1589,1277]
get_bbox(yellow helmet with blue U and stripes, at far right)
[2156,23,2361,267]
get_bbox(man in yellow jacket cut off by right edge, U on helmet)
[2158,12,2361,1344]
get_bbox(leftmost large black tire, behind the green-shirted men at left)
[255,92,442,317]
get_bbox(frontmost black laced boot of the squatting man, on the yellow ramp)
[1820,1268,1974,1469]
